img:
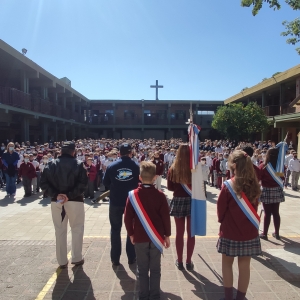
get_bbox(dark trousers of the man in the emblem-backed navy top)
[109,205,135,262]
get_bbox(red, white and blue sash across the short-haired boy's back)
[128,189,164,253]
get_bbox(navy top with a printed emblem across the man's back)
[103,156,140,207]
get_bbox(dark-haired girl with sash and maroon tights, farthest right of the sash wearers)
[259,142,286,240]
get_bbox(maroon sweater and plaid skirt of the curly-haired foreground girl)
[217,184,262,256]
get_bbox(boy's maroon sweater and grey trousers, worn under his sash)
[124,184,171,299]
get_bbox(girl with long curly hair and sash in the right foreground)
[217,150,261,300]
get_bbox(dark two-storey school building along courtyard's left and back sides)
[0,40,223,142]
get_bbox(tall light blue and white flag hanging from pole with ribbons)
[188,124,206,236]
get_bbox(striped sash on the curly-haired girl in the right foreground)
[224,179,260,230]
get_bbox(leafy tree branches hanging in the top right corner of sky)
[241,0,300,55]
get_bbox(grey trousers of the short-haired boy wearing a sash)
[135,242,161,300]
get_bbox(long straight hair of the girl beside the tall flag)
[169,144,192,184]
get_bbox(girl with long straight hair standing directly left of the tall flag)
[167,144,195,270]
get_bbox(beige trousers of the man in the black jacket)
[51,201,85,266]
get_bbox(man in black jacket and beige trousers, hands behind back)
[40,142,88,269]
